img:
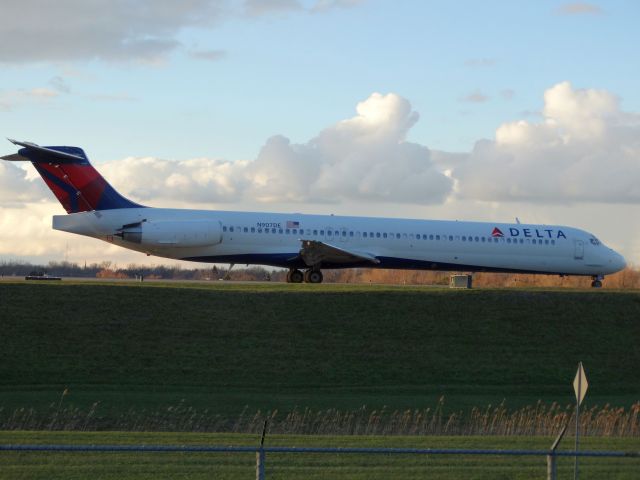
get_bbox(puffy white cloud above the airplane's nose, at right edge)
[453,82,640,203]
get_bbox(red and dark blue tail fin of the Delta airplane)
[0,139,143,213]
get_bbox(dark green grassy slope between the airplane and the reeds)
[0,281,640,430]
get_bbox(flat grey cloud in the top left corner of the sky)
[0,0,228,63]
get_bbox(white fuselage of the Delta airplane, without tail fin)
[53,208,625,275]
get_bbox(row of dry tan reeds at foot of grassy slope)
[0,399,640,437]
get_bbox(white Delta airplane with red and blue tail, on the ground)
[0,139,626,288]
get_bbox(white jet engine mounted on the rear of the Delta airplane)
[114,220,222,247]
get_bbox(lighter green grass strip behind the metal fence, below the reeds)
[0,432,640,480]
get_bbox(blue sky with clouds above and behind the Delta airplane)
[0,0,640,266]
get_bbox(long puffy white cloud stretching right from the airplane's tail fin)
[96,93,453,204]
